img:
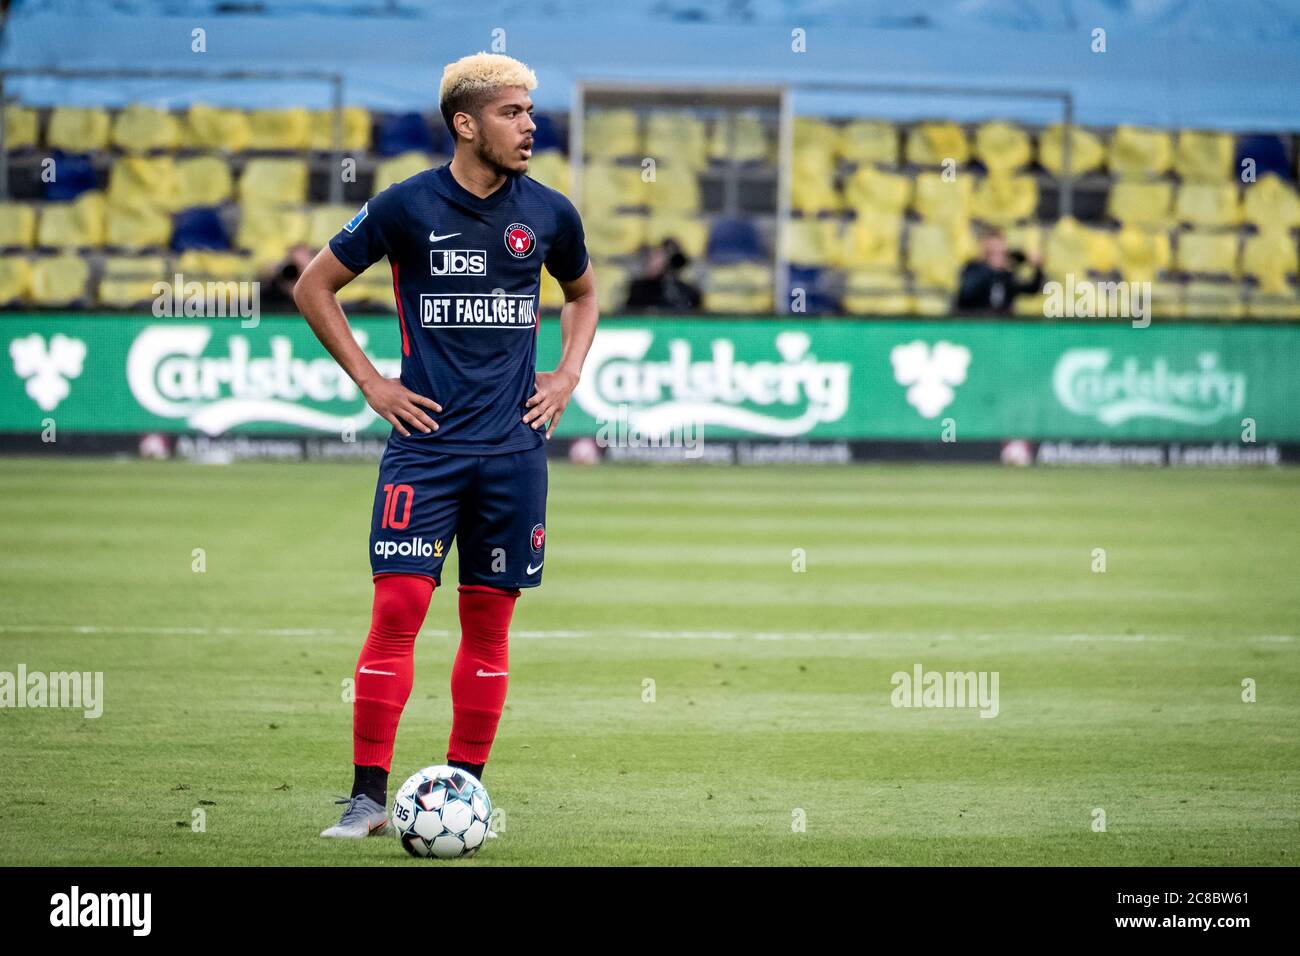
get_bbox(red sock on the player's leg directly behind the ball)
[447,584,519,763]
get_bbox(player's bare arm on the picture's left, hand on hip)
[294,246,442,436]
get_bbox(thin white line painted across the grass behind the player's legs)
[0,624,1296,644]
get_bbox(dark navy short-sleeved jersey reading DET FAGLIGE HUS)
[329,166,588,455]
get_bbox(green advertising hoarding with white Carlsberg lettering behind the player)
[0,315,1300,442]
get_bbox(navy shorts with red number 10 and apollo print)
[371,441,546,589]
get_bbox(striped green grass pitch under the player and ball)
[0,459,1300,866]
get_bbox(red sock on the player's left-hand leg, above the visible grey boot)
[352,574,433,770]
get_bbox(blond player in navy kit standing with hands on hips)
[294,53,597,838]
